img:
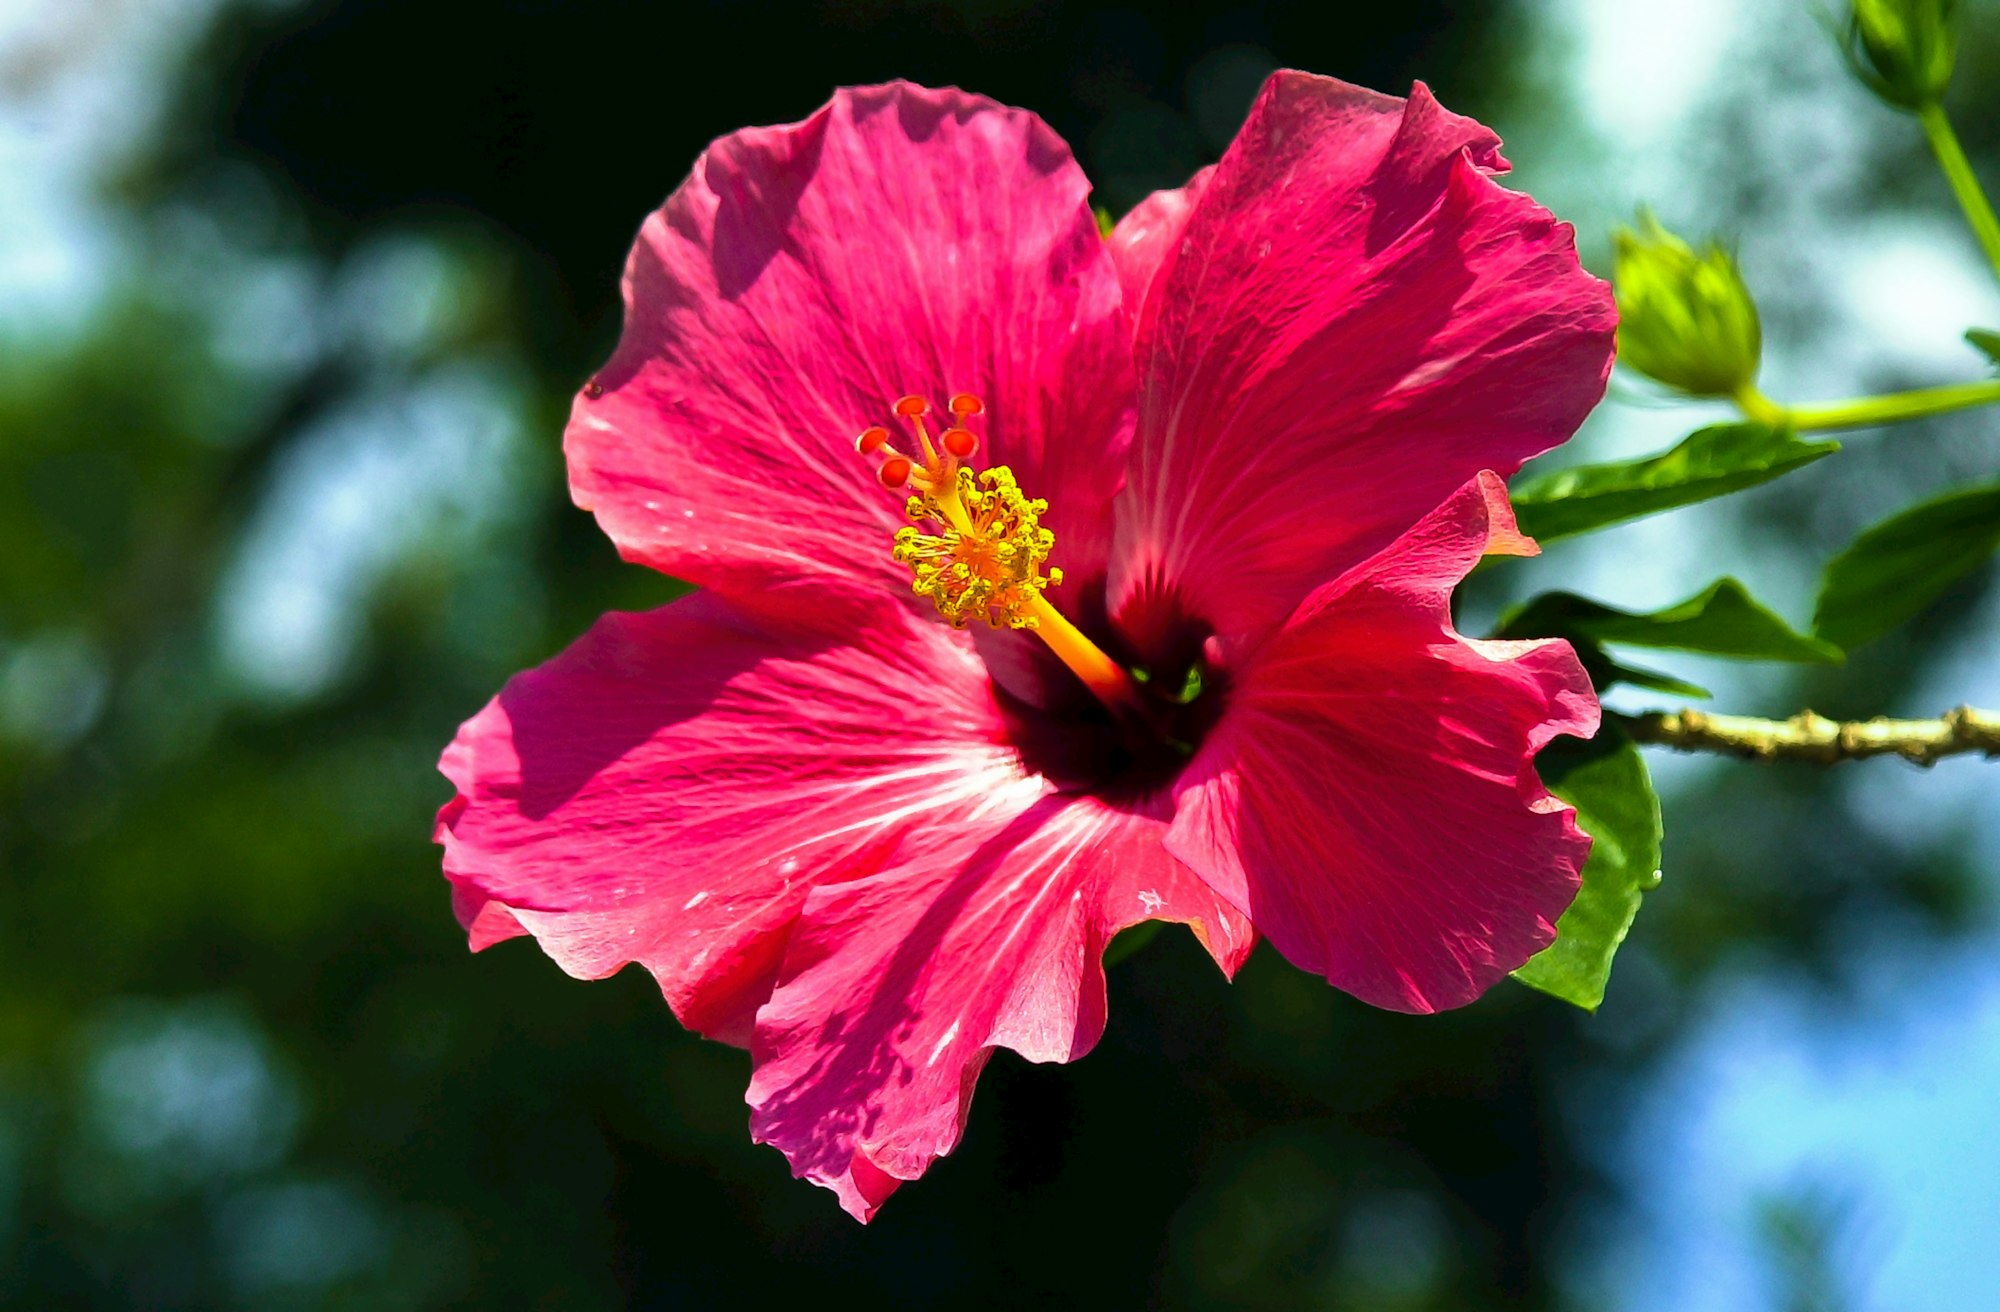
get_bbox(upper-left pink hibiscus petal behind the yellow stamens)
[564,82,1132,604]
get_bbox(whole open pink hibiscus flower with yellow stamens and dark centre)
[438,72,1614,1220]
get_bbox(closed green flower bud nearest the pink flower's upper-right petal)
[1612,210,1764,396]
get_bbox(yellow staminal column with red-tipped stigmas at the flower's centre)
[856,396,1148,720]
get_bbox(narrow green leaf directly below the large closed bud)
[1510,424,1840,542]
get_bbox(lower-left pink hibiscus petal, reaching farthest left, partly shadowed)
[438,594,1038,1044]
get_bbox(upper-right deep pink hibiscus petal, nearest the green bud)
[1110,72,1614,654]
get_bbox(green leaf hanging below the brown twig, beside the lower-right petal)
[1514,728,1660,1012]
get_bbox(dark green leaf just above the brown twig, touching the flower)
[1500,578,1844,668]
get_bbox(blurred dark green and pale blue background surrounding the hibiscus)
[0,0,2000,1312]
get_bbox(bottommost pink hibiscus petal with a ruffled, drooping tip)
[750,786,1254,1220]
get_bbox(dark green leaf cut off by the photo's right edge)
[1812,482,2000,648]
